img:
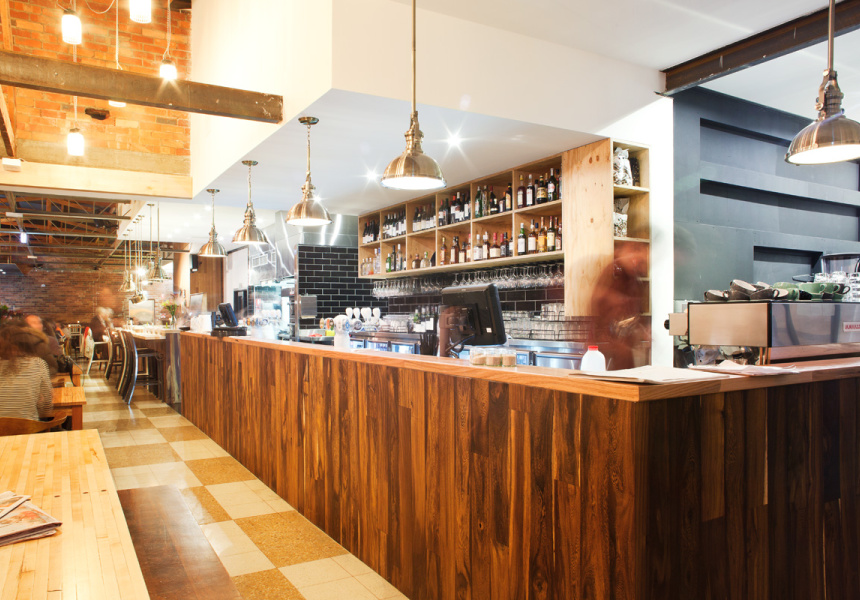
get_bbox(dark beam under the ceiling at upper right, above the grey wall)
[663,0,860,94]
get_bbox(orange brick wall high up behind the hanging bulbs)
[0,0,191,160]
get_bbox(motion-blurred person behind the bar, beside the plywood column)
[591,244,651,371]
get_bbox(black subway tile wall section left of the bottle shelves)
[297,245,387,328]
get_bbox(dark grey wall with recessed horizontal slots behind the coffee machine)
[674,89,860,300]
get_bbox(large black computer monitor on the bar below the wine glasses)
[439,283,507,355]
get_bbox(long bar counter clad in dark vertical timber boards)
[181,333,860,600]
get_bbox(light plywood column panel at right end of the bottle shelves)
[561,139,615,317]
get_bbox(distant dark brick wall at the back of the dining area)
[0,269,173,323]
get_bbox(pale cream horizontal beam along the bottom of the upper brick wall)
[0,162,191,199]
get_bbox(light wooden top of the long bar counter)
[183,332,860,402]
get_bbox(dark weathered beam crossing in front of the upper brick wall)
[0,51,284,123]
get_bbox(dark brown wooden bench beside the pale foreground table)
[118,486,242,600]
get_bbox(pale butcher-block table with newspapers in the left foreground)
[0,429,149,600]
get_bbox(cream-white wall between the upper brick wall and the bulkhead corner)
[190,0,332,195]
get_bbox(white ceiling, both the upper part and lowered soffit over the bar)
[5,0,860,258]
